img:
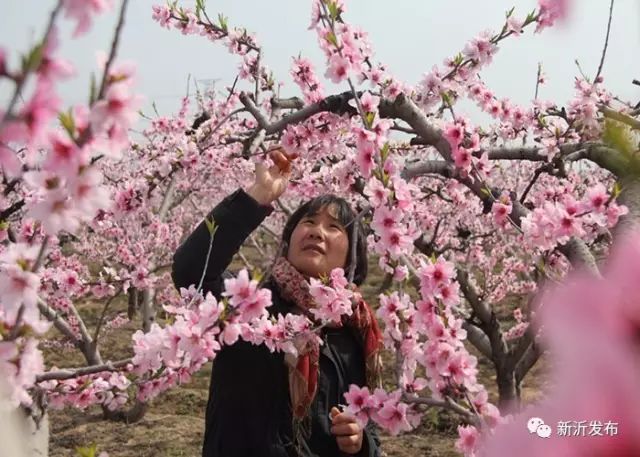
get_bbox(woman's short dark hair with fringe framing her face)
[282,194,368,286]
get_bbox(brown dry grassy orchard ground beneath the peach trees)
[45,253,545,457]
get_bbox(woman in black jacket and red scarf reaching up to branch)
[172,151,380,457]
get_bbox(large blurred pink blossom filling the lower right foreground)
[479,232,640,457]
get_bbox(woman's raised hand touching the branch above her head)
[247,148,296,205]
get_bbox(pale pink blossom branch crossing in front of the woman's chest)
[126,269,320,400]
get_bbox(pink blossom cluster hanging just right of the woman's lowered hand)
[345,258,502,448]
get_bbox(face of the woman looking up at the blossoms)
[287,206,349,278]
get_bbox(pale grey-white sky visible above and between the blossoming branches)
[0,0,640,127]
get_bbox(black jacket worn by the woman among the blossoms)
[172,190,379,457]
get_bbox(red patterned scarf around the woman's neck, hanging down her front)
[271,257,382,419]
